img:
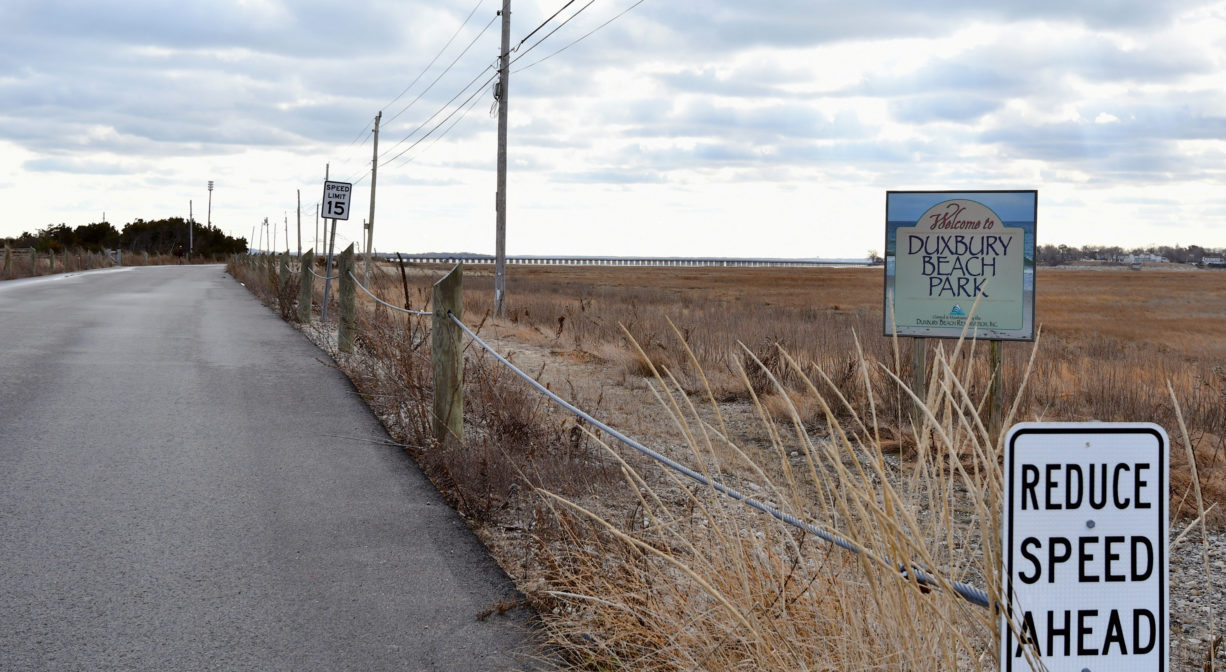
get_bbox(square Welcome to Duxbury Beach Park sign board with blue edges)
[885,191,1037,341]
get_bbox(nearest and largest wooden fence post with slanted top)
[430,262,463,446]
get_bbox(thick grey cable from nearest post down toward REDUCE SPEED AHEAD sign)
[447,311,992,607]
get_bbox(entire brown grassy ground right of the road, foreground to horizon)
[230,255,1226,671]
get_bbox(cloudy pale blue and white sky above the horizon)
[0,0,1226,258]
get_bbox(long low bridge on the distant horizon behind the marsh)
[376,253,869,267]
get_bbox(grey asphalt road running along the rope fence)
[0,266,527,671]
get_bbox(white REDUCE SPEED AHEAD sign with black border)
[1000,423,1170,672]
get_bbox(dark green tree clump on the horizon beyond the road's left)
[4,217,246,256]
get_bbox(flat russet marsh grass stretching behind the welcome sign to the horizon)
[453,266,1226,526]
